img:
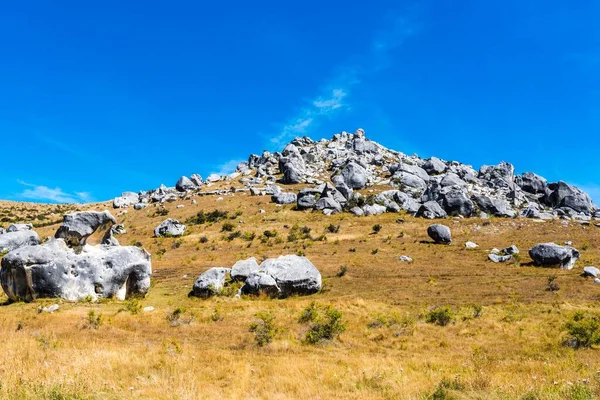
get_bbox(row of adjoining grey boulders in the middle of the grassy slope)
[190,255,322,298]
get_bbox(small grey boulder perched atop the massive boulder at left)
[54,211,117,245]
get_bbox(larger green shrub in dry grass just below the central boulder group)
[298,301,346,344]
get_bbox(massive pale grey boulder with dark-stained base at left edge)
[0,239,152,301]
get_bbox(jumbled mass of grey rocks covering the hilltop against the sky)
[114,129,600,221]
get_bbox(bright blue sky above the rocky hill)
[0,0,600,202]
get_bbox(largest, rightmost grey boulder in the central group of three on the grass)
[241,255,321,297]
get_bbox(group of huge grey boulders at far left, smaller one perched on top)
[0,211,152,301]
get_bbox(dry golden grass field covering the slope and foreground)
[0,188,600,399]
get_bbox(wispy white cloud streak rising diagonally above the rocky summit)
[270,10,421,149]
